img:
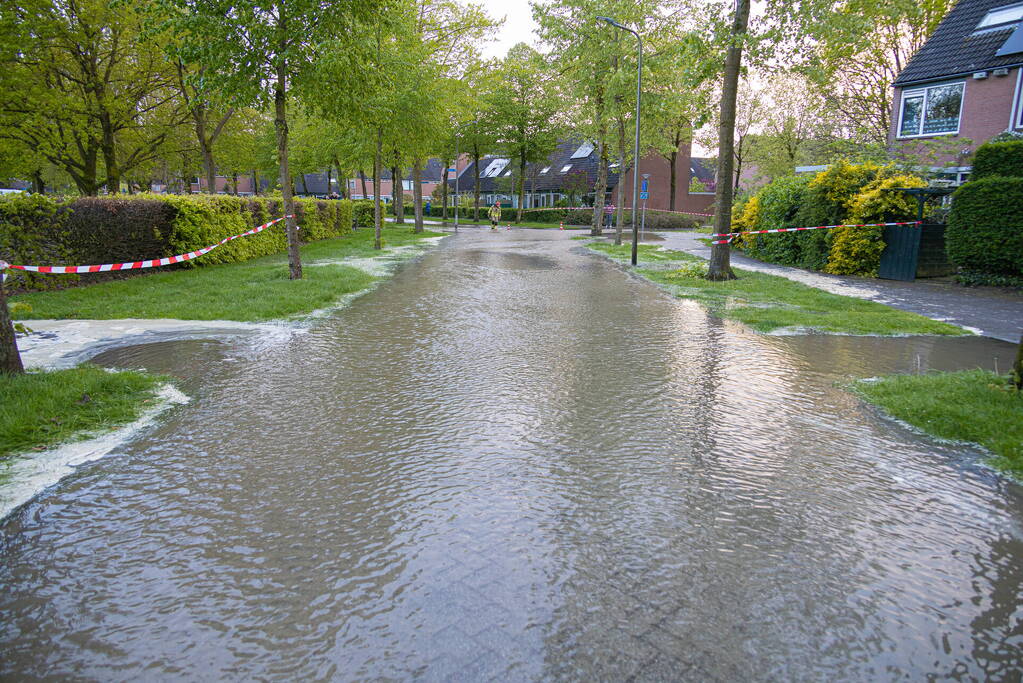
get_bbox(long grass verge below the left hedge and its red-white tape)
[11,227,443,322]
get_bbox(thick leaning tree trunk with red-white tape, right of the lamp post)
[707,0,750,280]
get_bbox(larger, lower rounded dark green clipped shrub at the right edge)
[945,176,1023,277]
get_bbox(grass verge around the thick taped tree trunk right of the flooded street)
[587,243,968,335]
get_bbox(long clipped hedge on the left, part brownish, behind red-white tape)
[0,194,352,289]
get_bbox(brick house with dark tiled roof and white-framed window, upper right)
[889,0,1023,184]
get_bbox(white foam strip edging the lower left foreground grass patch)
[0,384,188,519]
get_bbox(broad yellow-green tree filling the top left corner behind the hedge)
[0,0,184,194]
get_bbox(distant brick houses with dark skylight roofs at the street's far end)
[448,140,714,213]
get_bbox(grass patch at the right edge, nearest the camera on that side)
[852,370,1023,477]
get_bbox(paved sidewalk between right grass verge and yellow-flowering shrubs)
[658,232,1023,343]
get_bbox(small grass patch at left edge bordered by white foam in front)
[0,365,167,458]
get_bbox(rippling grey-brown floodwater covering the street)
[0,230,1023,681]
